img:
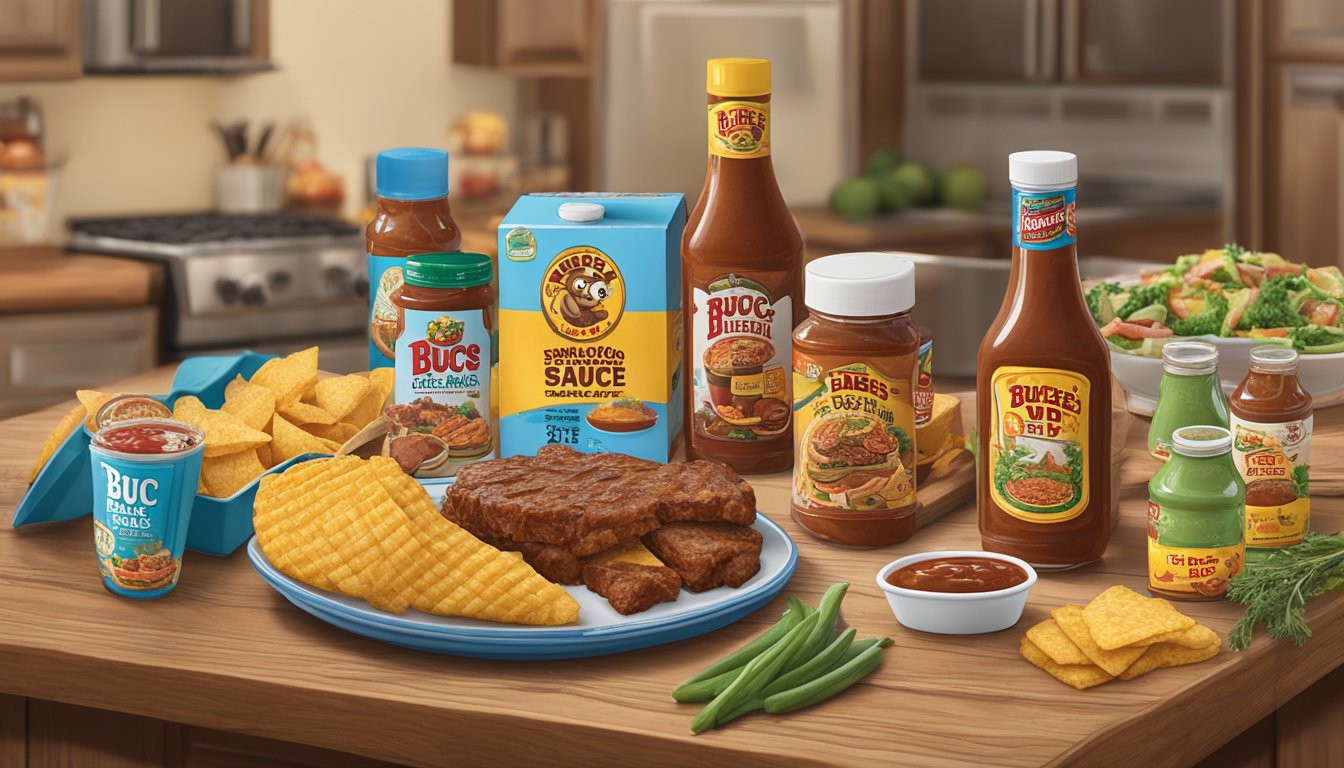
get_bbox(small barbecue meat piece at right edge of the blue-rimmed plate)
[644,522,761,592]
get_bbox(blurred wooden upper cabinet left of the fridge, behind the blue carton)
[453,0,599,77]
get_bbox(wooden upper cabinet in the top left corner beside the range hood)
[0,0,79,82]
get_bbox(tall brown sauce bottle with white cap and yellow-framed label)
[976,151,1111,569]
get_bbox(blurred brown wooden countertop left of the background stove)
[0,246,164,313]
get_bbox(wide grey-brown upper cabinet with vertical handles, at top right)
[910,0,1232,86]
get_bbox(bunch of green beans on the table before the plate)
[672,584,891,733]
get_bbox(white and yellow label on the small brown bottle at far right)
[1231,414,1312,546]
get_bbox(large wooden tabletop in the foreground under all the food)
[0,369,1344,768]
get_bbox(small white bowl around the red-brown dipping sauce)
[878,550,1036,635]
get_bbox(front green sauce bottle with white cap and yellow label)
[1148,425,1246,600]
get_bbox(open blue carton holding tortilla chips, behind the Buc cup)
[13,352,334,557]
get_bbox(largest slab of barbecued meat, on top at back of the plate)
[442,445,755,557]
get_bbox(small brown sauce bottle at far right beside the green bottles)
[1228,346,1313,561]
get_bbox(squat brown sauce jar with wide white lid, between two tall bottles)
[790,253,919,546]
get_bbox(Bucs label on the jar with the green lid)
[386,309,495,477]
